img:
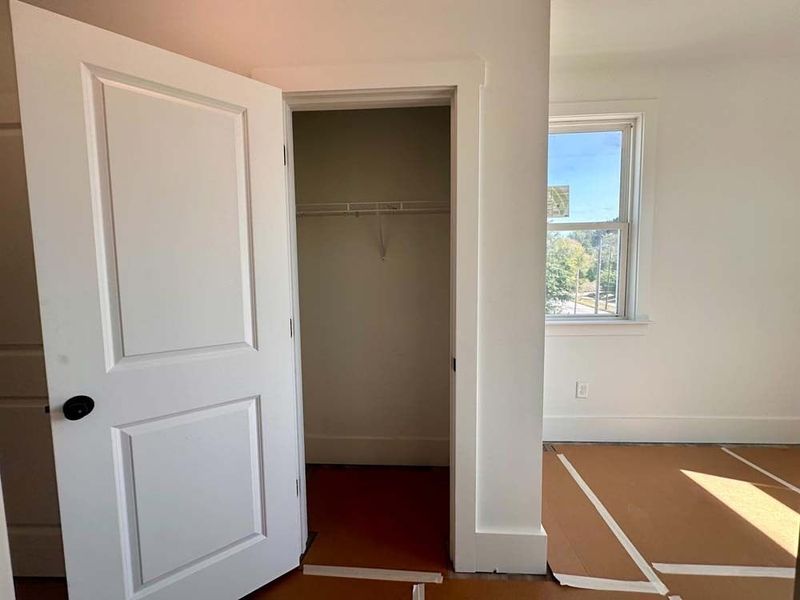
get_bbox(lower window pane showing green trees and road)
[545,229,620,317]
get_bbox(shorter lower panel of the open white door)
[114,398,267,589]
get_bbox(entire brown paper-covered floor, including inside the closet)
[17,444,800,600]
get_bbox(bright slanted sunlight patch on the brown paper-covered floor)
[681,469,800,558]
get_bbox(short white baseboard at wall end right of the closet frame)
[475,527,547,575]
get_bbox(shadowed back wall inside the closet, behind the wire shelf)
[293,106,450,465]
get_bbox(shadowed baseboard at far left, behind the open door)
[8,525,65,577]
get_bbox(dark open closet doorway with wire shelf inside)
[287,100,454,571]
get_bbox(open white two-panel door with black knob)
[11,0,300,600]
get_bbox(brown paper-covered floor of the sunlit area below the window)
[542,444,800,600]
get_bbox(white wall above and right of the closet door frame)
[9,0,549,570]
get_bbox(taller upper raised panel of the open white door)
[84,68,255,367]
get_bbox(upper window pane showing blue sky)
[547,131,622,223]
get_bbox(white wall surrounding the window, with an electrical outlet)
[545,58,800,443]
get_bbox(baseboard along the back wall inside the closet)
[305,434,450,467]
